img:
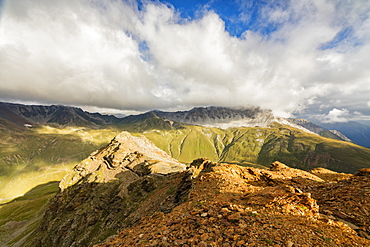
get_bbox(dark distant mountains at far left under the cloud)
[0,102,119,127]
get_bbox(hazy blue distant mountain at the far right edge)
[320,121,370,148]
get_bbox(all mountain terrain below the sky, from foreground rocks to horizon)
[0,103,370,246]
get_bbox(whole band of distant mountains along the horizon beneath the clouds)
[0,102,370,147]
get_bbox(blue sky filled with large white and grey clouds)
[0,0,370,124]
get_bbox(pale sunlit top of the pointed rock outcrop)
[60,131,186,190]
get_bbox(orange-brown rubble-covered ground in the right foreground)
[96,159,370,247]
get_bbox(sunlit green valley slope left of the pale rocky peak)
[0,126,117,202]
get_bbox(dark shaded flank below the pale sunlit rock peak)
[33,170,188,247]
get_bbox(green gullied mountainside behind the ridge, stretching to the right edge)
[143,124,370,173]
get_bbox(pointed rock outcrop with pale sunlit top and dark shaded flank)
[32,132,186,246]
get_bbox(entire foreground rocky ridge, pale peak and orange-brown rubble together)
[24,132,370,247]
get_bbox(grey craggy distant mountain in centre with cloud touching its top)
[154,106,275,128]
